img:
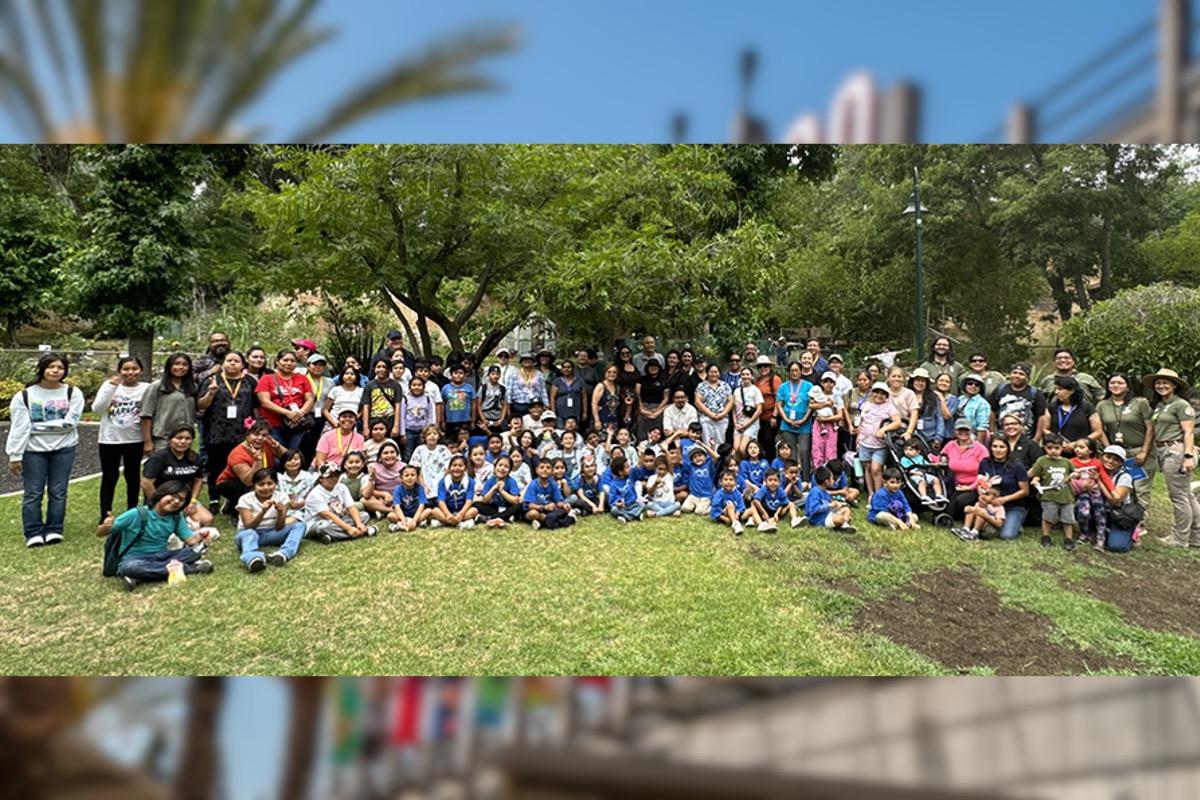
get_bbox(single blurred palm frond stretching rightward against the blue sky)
[292,28,518,142]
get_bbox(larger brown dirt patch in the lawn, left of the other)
[854,570,1134,675]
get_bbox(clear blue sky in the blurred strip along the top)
[0,0,1180,142]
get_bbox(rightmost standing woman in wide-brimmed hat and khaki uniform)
[1142,369,1200,547]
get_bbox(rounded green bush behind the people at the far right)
[1062,283,1200,385]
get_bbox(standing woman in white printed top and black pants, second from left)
[91,355,150,522]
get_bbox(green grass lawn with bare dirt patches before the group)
[0,480,1200,675]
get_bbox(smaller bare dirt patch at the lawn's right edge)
[1081,553,1200,637]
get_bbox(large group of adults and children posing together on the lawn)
[7,331,1200,588]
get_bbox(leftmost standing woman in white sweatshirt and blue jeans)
[5,353,83,547]
